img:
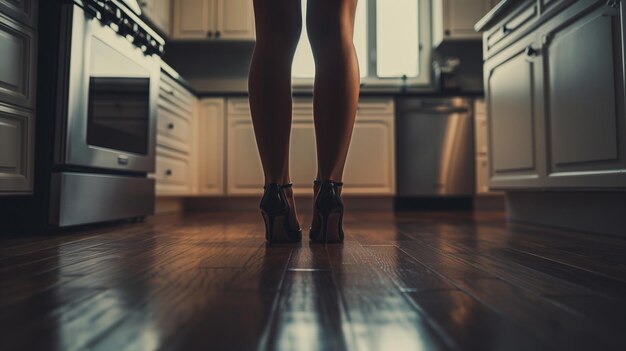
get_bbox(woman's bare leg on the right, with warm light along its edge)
[307,0,359,186]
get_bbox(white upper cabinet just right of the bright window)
[432,0,495,46]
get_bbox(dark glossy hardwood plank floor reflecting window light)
[0,211,626,351]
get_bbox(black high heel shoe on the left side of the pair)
[259,183,302,245]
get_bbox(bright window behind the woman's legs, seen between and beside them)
[292,0,430,83]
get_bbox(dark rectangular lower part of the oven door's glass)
[87,77,150,155]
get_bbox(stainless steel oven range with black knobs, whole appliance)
[49,0,164,227]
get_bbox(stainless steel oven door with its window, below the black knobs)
[57,5,161,173]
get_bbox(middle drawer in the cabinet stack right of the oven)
[157,106,191,152]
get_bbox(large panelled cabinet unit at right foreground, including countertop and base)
[475,0,626,235]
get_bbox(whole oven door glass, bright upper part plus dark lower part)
[87,36,151,155]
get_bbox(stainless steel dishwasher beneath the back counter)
[396,98,475,198]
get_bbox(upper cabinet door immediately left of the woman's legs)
[216,0,255,40]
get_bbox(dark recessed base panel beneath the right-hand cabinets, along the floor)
[506,192,626,236]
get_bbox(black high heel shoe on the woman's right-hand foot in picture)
[309,180,344,245]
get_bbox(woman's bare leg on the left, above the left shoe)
[248,0,302,228]
